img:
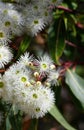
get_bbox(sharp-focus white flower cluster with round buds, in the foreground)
[0,53,59,118]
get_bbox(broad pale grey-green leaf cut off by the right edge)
[66,69,84,107]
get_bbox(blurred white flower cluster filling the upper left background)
[0,0,61,68]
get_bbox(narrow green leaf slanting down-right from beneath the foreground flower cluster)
[49,105,76,130]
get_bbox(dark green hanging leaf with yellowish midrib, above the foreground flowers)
[48,18,66,64]
